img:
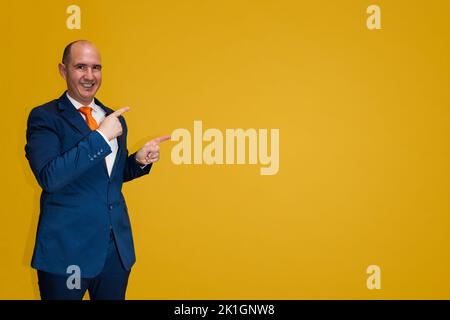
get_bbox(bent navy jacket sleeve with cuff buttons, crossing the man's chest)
[25,108,112,192]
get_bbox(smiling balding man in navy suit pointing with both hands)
[25,40,170,300]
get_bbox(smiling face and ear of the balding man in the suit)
[59,42,102,105]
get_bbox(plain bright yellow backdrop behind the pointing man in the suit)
[0,0,450,299]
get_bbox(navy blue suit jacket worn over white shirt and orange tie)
[25,93,151,278]
